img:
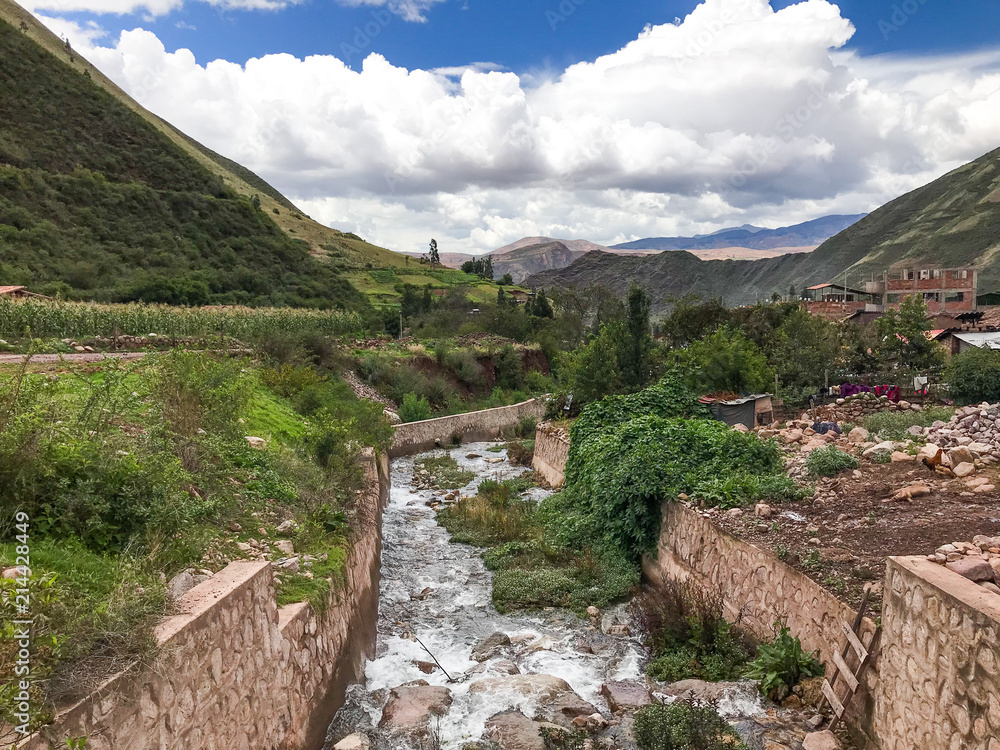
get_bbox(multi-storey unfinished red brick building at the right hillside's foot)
[865,264,978,315]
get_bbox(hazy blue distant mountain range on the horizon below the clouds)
[611,214,865,251]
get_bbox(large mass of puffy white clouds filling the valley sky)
[37,0,1000,251]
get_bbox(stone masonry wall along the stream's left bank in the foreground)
[17,454,389,750]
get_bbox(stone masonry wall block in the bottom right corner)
[875,557,1000,750]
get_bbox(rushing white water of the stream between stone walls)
[366,443,643,749]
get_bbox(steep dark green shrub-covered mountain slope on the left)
[0,0,405,309]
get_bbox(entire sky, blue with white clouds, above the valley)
[20,0,1000,253]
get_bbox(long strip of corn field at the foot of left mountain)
[0,299,364,341]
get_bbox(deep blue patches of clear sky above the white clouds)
[45,0,1000,73]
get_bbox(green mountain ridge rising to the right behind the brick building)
[524,149,1000,312]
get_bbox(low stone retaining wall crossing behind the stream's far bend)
[389,398,545,458]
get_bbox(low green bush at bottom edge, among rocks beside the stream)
[635,701,747,750]
